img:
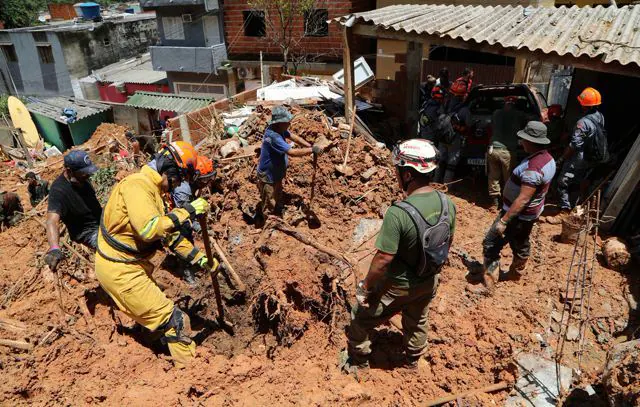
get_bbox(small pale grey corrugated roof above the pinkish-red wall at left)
[89,53,167,85]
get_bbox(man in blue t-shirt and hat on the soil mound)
[256,106,323,223]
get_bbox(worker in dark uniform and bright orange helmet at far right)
[558,88,609,212]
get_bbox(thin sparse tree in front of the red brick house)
[248,0,321,72]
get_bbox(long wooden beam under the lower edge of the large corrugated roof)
[353,23,640,78]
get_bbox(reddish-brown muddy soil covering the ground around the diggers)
[0,110,628,406]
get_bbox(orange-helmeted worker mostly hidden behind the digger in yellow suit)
[171,155,216,286]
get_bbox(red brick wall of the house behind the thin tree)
[224,0,375,61]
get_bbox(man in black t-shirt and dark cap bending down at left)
[44,150,102,269]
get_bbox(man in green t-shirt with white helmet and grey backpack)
[343,139,455,370]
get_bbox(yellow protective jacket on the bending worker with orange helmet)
[98,165,204,264]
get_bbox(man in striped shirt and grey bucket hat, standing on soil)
[482,121,556,293]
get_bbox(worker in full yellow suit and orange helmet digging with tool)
[95,141,217,367]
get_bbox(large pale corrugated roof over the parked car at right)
[336,4,640,66]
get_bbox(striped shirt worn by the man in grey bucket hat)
[502,150,556,221]
